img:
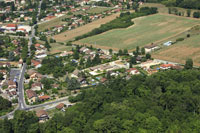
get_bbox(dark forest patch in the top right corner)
[146,0,200,9]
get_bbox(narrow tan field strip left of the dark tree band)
[53,13,120,42]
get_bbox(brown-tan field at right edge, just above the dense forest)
[153,35,200,66]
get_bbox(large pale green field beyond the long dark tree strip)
[80,14,200,50]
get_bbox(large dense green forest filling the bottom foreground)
[0,70,200,133]
